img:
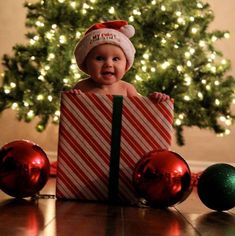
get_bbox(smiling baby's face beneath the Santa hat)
[86,44,127,85]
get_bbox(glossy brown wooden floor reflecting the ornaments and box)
[0,178,235,236]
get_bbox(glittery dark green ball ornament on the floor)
[197,163,235,211]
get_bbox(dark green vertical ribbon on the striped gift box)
[108,95,123,203]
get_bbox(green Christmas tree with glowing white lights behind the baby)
[0,0,235,145]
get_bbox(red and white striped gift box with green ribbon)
[56,92,173,203]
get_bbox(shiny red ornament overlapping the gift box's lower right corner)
[133,150,192,208]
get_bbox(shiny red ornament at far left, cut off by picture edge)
[0,140,50,198]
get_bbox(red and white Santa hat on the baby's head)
[74,20,135,73]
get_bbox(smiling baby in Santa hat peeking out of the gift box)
[74,20,169,101]
